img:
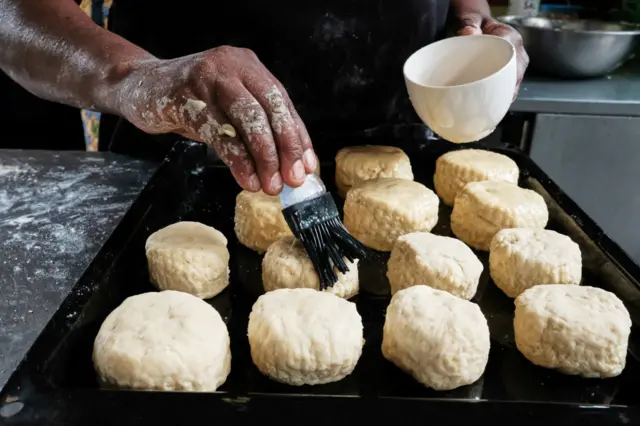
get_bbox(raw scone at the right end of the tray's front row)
[513,284,631,378]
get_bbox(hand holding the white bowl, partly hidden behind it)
[458,12,529,100]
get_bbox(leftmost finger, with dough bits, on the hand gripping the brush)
[174,108,261,192]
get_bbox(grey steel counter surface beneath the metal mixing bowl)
[511,69,640,116]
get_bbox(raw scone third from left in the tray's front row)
[382,285,490,390]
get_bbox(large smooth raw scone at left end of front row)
[93,290,231,392]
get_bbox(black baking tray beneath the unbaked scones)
[0,138,640,426]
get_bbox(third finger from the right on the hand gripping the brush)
[216,81,283,195]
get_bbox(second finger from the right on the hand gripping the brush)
[244,72,307,187]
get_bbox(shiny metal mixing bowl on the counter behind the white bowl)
[498,16,640,78]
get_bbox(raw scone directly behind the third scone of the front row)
[387,232,484,300]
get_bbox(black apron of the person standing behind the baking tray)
[100,0,449,158]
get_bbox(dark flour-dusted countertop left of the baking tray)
[0,150,156,389]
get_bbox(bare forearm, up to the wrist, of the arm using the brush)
[0,0,153,114]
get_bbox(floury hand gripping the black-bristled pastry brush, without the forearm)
[120,46,317,195]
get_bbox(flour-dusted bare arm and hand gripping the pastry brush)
[0,0,317,195]
